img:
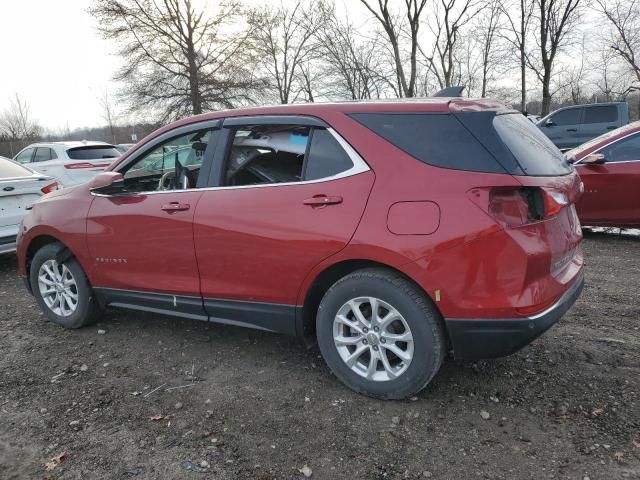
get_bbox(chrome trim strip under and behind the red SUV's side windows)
[91,127,371,197]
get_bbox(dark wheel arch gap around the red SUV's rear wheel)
[297,258,449,342]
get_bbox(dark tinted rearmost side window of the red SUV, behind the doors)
[350,113,504,173]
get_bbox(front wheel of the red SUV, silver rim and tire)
[30,243,99,328]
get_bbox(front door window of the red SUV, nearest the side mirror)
[119,129,212,192]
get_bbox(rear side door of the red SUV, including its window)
[194,117,374,333]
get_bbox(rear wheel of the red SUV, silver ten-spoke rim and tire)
[316,269,445,399]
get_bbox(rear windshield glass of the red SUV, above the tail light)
[493,113,572,176]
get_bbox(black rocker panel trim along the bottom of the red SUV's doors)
[93,288,298,335]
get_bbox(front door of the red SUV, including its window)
[87,122,220,315]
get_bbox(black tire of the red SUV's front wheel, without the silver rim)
[29,242,100,328]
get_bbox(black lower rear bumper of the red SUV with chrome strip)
[446,272,584,360]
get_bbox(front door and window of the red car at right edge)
[576,133,640,226]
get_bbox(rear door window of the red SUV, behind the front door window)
[223,125,353,186]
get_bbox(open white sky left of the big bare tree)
[0,0,124,130]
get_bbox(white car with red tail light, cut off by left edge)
[0,157,60,254]
